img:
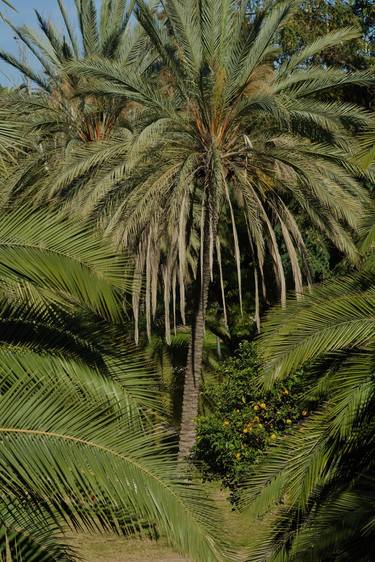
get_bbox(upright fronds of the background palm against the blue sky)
[0,0,144,91]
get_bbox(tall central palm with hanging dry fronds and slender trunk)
[3,0,374,456]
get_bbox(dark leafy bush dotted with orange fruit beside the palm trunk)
[193,342,308,497]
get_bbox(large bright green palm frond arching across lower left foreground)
[0,372,226,562]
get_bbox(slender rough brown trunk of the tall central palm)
[178,213,212,460]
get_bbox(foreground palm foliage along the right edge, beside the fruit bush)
[247,220,375,562]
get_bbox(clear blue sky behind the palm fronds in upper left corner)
[0,0,87,85]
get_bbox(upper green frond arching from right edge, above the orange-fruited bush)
[261,271,375,382]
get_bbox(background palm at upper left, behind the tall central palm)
[0,0,159,211]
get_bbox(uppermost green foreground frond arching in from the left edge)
[0,209,126,318]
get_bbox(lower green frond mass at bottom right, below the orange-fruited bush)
[243,350,374,561]
